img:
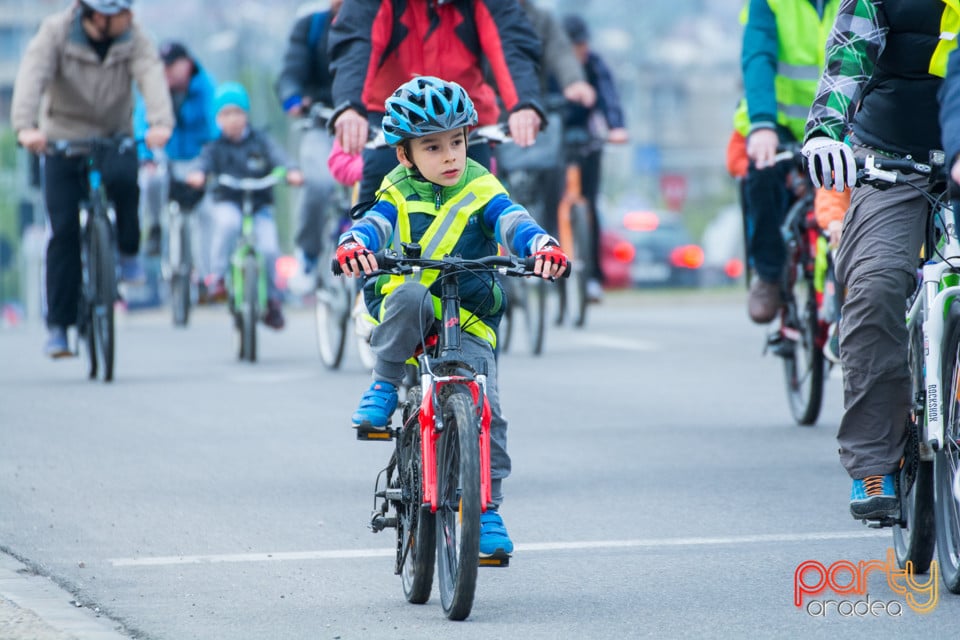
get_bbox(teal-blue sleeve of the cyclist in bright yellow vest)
[740,0,778,126]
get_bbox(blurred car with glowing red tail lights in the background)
[600,210,703,287]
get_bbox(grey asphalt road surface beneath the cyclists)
[0,291,960,640]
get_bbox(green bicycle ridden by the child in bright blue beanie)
[215,168,286,362]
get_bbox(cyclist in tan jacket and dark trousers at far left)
[11,0,174,358]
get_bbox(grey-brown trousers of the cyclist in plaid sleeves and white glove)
[836,148,928,479]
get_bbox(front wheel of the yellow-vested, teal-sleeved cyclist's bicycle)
[783,262,825,426]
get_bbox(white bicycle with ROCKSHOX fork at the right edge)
[857,152,960,593]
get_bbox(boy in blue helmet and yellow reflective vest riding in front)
[337,76,567,555]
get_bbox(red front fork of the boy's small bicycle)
[419,376,492,513]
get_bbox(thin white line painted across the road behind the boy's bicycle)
[107,531,890,567]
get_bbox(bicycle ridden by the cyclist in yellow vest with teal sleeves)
[765,145,837,426]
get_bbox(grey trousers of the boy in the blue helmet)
[370,282,510,505]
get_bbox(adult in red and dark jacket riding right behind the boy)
[328,0,543,201]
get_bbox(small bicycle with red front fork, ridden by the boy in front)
[334,244,564,620]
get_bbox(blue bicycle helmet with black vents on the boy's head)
[383,76,477,146]
